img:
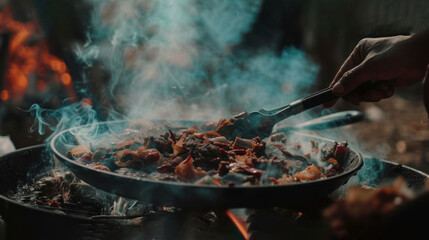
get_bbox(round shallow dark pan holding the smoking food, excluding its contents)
[50,116,363,208]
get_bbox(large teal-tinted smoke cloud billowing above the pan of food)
[76,0,318,119]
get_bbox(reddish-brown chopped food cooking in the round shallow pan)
[68,120,349,186]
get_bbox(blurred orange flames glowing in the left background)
[0,7,75,101]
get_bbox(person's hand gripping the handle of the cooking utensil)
[324,31,429,107]
